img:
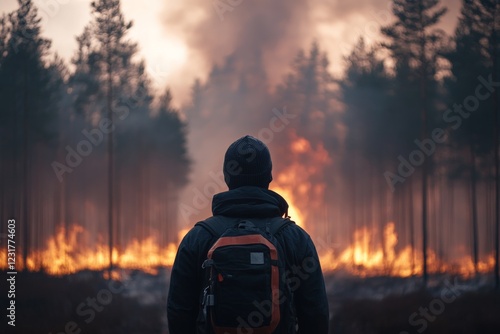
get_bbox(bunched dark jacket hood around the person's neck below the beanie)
[212,186,288,218]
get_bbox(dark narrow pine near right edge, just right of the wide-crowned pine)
[446,0,493,272]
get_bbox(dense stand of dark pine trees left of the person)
[0,0,189,268]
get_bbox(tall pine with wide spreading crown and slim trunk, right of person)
[382,0,446,286]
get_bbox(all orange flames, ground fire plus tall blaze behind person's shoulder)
[0,131,494,277]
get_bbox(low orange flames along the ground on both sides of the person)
[0,222,494,277]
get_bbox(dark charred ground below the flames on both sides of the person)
[0,270,500,334]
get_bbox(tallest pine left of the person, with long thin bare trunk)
[70,0,138,270]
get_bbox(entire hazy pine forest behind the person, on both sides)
[0,0,500,284]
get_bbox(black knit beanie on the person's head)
[223,135,273,189]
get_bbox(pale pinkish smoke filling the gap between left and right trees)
[162,0,460,240]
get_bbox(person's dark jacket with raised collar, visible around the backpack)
[167,187,329,334]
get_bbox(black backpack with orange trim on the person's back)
[196,216,295,334]
